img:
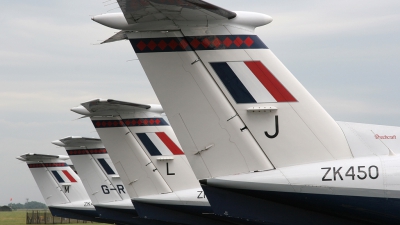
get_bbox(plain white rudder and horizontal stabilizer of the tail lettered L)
[71,99,172,198]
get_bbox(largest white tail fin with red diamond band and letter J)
[119,14,352,179]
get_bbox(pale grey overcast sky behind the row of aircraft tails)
[0,0,400,205]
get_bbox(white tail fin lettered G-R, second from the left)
[52,137,133,208]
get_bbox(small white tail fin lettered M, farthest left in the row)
[18,153,93,209]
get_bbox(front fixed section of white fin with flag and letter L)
[112,107,200,192]
